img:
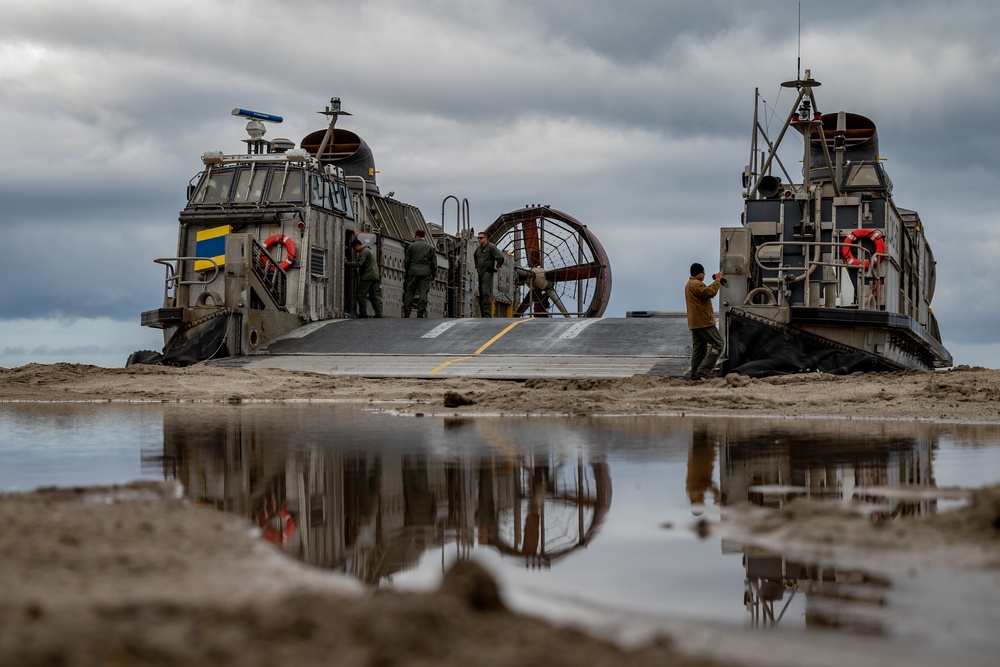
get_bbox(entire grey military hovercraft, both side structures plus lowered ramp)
[128,70,951,379]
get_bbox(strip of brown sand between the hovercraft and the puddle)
[0,364,1000,423]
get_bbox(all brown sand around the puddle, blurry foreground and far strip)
[0,364,1000,666]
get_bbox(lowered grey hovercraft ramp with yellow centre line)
[209,314,691,380]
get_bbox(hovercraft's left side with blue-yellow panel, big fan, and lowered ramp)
[128,98,700,378]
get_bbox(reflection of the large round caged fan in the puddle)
[487,461,611,567]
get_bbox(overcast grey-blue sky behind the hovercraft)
[0,0,1000,368]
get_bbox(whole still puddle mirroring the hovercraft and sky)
[0,404,1000,655]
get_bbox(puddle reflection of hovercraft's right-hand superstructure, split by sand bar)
[720,422,938,635]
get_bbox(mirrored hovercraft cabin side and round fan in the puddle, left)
[146,407,611,584]
